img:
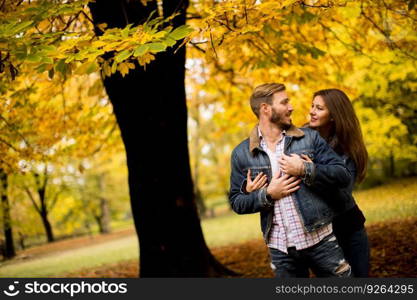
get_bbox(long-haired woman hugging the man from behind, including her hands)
[246,89,369,277]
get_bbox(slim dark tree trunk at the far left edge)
[0,169,16,258]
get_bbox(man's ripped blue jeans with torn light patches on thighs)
[269,233,352,278]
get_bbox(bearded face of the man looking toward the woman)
[269,91,294,130]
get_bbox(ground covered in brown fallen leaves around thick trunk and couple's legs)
[67,218,417,278]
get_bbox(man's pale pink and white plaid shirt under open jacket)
[259,130,332,253]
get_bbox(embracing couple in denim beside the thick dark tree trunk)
[229,83,369,277]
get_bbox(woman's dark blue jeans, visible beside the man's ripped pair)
[336,228,369,277]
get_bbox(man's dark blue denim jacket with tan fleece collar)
[229,126,350,240]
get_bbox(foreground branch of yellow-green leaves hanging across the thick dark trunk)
[0,0,193,78]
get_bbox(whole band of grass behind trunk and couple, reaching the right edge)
[0,178,417,277]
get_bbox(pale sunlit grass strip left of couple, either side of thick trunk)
[0,214,261,277]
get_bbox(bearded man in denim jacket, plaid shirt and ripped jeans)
[229,83,351,277]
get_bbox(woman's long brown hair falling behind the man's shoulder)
[313,89,368,182]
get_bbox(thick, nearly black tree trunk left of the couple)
[89,0,234,277]
